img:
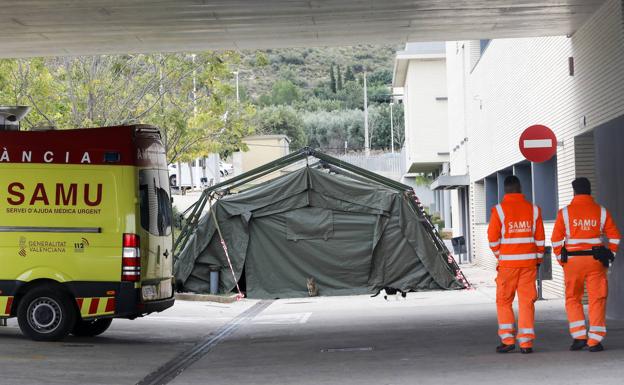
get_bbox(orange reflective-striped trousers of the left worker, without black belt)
[496,266,537,348]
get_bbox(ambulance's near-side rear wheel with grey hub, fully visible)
[17,286,76,341]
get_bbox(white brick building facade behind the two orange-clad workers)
[446,0,624,317]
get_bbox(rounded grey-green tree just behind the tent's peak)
[256,105,308,150]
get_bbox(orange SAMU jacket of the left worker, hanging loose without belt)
[488,194,544,267]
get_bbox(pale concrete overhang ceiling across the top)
[0,0,604,57]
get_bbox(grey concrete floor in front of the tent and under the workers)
[0,268,624,385]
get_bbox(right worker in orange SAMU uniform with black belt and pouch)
[551,178,620,352]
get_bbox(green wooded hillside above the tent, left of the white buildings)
[234,46,404,153]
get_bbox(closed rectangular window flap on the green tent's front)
[286,207,334,241]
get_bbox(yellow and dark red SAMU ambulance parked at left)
[0,125,174,341]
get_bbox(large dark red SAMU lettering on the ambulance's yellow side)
[7,182,102,207]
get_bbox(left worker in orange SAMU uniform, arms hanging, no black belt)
[488,176,544,354]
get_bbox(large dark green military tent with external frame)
[175,149,468,298]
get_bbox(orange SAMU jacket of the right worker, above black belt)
[551,194,620,260]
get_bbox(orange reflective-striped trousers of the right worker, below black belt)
[563,256,609,346]
